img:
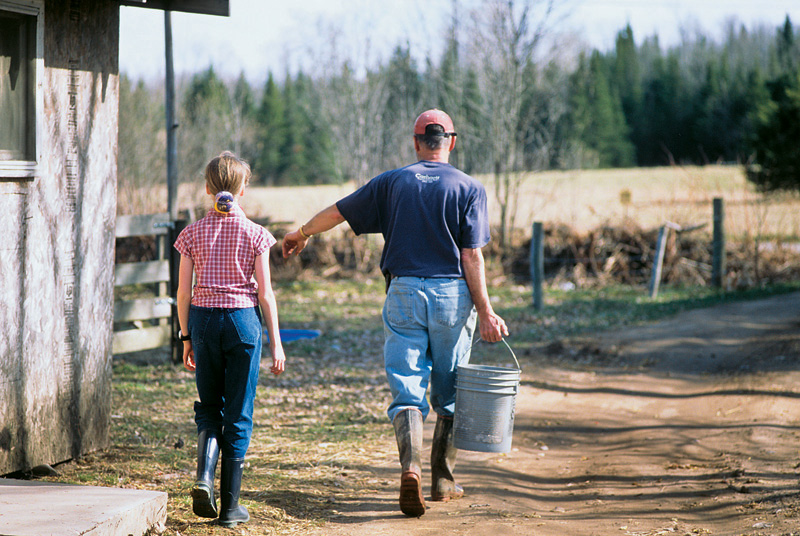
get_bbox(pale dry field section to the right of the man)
[489,166,800,239]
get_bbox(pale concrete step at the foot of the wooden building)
[0,478,167,536]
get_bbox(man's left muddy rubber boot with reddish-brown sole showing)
[392,409,425,517]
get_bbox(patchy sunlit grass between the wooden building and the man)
[48,282,395,536]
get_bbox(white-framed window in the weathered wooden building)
[0,0,41,178]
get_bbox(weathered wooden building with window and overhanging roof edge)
[0,0,228,474]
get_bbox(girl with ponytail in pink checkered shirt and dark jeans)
[175,151,286,527]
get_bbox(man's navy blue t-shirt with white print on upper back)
[336,160,490,277]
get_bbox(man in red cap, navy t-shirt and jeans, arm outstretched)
[283,110,508,517]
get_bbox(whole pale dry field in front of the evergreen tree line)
[161,166,800,241]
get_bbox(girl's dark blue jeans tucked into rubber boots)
[189,305,262,458]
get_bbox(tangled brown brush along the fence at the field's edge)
[116,221,800,289]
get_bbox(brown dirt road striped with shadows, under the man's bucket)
[308,293,800,536]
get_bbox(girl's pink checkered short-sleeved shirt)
[175,205,275,309]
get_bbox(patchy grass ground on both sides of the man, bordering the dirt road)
[26,281,798,536]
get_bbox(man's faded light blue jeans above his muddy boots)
[383,277,477,420]
